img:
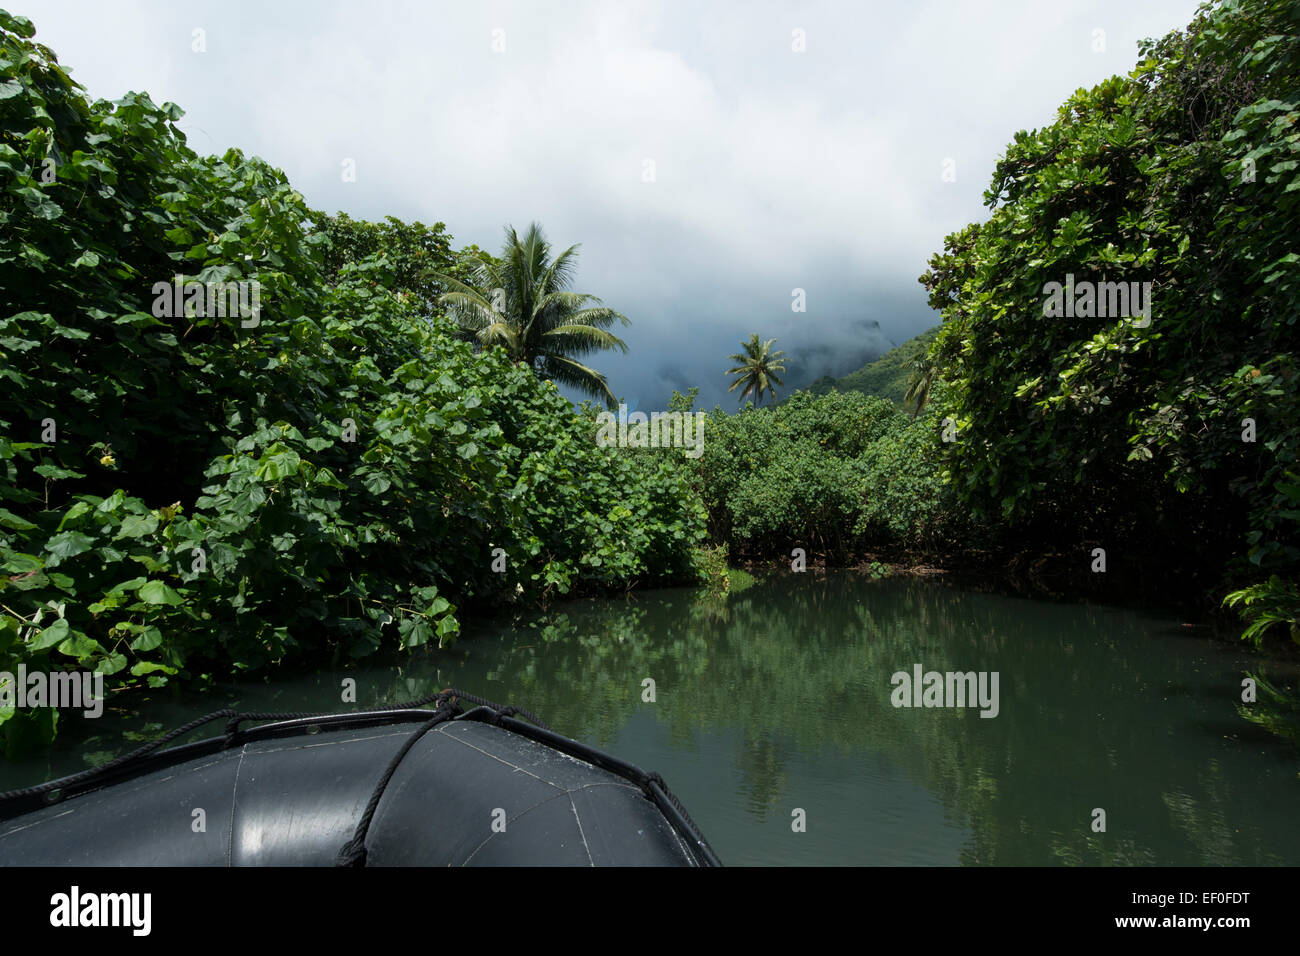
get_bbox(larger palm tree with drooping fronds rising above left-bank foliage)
[430,222,629,408]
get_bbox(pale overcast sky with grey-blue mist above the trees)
[25,0,1197,410]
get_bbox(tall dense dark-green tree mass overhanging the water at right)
[922,0,1300,636]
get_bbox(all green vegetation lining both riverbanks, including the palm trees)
[0,0,1300,750]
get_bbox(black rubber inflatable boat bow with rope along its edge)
[0,692,719,866]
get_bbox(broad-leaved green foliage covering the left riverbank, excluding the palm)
[0,13,703,749]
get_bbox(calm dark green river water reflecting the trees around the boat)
[0,572,1300,865]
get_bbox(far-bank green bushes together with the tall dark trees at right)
[698,0,1300,658]
